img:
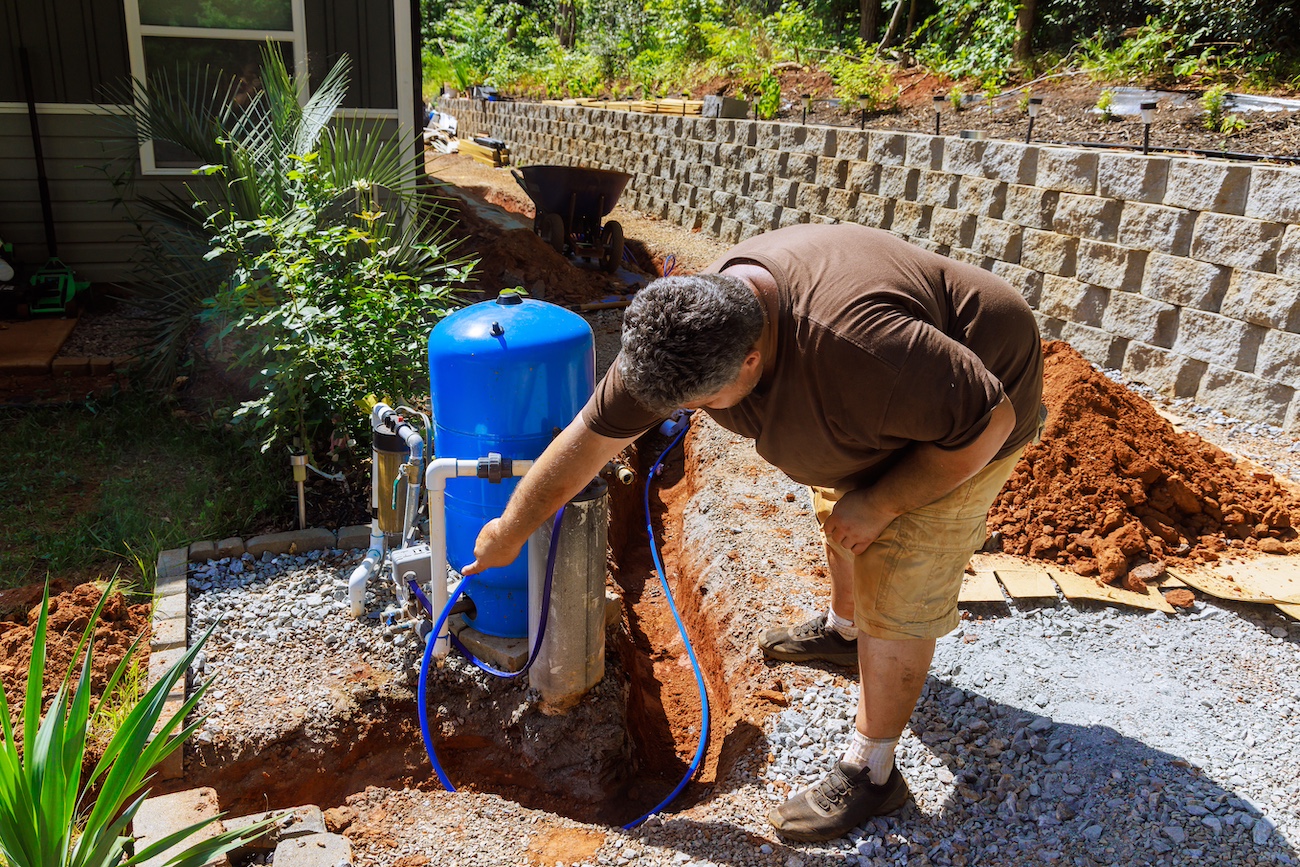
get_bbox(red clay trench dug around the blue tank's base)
[177,434,759,824]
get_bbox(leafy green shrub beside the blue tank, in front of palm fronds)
[205,161,468,451]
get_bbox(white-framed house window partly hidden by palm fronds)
[124,0,307,174]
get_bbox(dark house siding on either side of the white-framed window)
[0,0,405,283]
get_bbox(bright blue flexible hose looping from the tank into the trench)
[416,419,709,831]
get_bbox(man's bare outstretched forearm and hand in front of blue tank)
[462,416,636,575]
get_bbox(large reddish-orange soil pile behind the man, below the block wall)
[989,342,1300,591]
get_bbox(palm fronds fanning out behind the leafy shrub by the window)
[105,43,467,382]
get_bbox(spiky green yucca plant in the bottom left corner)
[0,586,274,867]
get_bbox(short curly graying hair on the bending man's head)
[619,274,763,415]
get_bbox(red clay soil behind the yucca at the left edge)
[0,584,150,711]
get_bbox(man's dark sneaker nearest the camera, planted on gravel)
[767,762,911,842]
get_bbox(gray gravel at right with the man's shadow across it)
[763,602,1300,864]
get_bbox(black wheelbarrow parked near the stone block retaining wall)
[511,165,632,272]
